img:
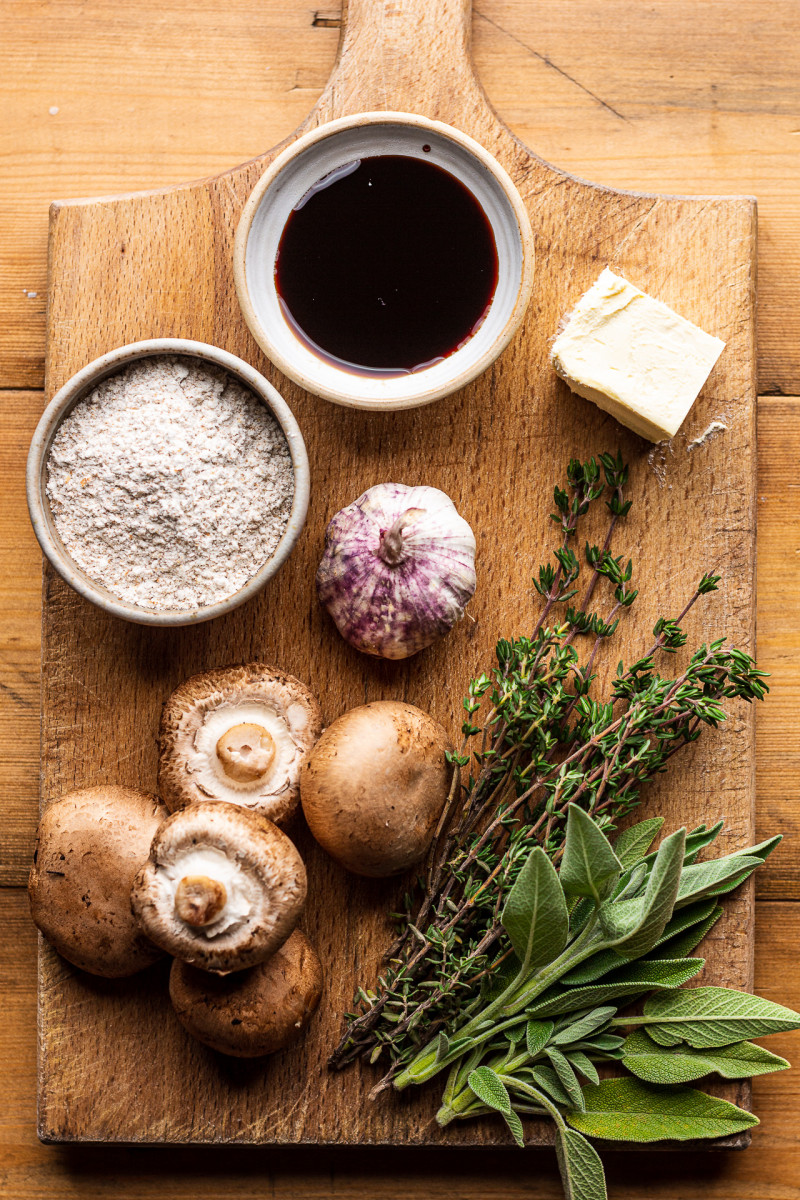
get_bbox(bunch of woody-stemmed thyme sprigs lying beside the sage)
[331,454,766,1096]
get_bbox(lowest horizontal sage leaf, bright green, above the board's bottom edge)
[565,1079,758,1142]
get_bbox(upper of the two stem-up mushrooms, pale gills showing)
[158,662,323,823]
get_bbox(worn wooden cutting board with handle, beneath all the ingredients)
[40,0,756,1145]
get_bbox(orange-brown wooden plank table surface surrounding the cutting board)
[0,0,800,1200]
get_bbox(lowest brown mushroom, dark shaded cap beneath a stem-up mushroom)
[169,929,323,1058]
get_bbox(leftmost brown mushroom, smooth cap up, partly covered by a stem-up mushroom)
[28,785,168,978]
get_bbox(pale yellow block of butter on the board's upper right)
[551,268,724,442]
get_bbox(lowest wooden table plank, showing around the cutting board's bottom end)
[0,889,800,1200]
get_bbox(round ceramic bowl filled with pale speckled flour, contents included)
[28,338,309,625]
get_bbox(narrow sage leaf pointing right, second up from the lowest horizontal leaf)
[623,1030,789,1084]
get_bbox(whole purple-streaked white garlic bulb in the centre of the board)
[317,484,475,659]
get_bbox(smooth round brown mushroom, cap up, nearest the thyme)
[301,700,452,876]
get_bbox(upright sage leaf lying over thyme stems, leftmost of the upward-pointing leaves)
[500,846,570,971]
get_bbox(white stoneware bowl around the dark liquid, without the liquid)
[234,113,534,410]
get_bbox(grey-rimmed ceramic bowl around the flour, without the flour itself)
[26,337,309,626]
